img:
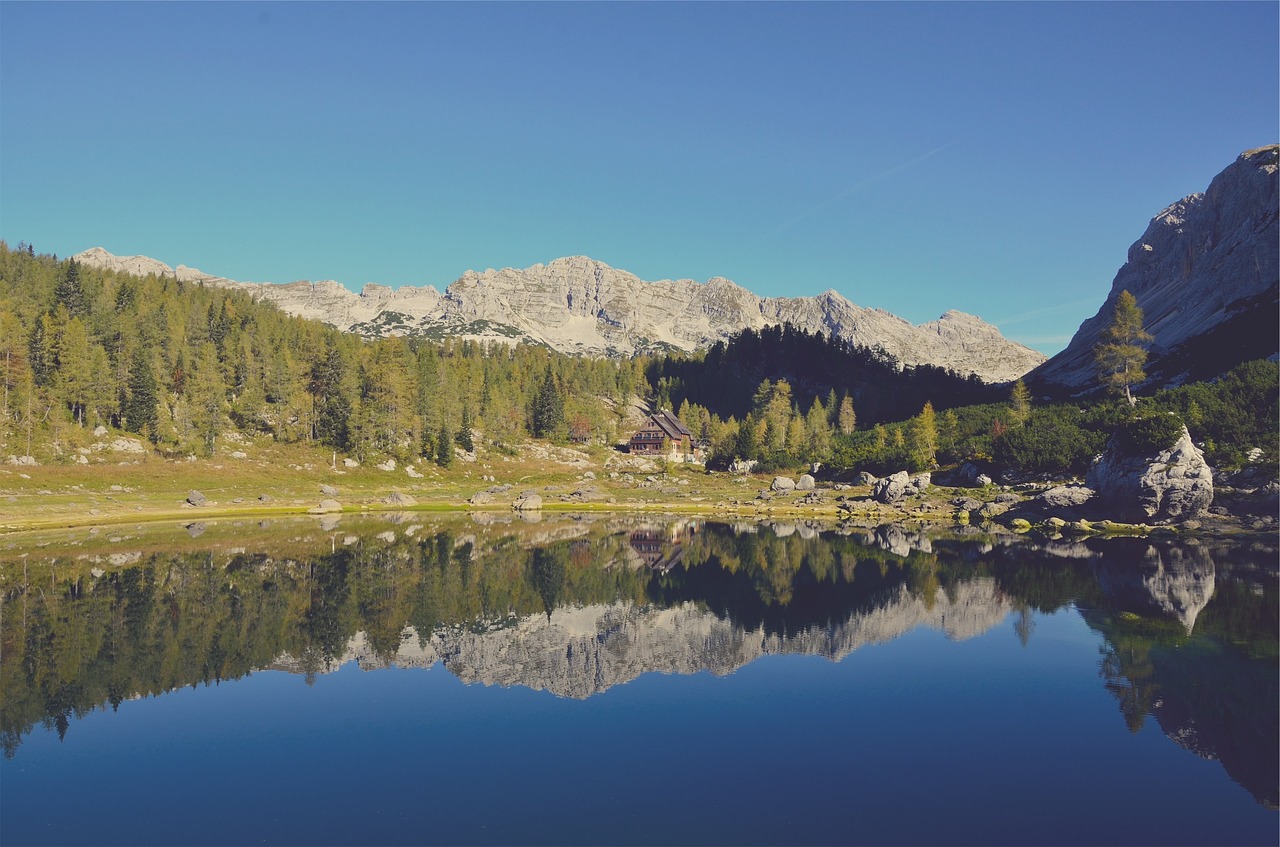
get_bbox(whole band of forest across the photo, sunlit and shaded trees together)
[0,242,1280,476]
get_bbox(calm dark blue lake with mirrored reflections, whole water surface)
[0,514,1280,846]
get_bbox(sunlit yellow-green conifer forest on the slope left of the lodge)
[0,242,648,462]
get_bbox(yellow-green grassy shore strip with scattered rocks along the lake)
[0,444,1276,544]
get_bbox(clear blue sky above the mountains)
[0,1,1280,353]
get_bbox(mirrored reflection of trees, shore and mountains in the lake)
[0,519,1277,806]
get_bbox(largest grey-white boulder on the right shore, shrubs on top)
[1085,426,1213,522]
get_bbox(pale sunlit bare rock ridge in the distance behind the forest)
[74,247,1044,383]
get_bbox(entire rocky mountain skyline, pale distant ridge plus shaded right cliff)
[74,145,1280,394]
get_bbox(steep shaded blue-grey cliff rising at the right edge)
[1028,145,1280,389]
